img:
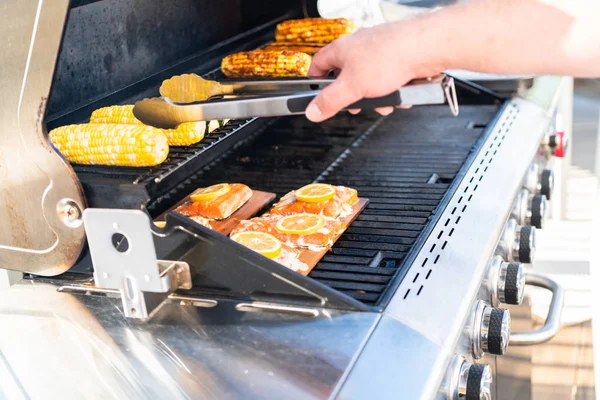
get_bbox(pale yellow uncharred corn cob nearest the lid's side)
[49,124,169,167]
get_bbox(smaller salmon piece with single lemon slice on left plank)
[175,183,252,220]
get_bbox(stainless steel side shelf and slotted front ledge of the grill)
[0,80,559,399]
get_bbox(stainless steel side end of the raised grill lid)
[0,0,85,275]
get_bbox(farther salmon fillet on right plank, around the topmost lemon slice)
[270,186,358,218]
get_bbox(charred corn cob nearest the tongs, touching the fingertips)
[221,50,311,78]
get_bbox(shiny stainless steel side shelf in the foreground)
[0,282,378,399]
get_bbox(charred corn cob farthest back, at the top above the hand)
[275,18,354,44]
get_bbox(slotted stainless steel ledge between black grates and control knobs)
[386,99,549,347]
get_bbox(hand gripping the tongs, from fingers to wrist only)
[306,20,442,122]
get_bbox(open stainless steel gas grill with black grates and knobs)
[0,0,570,399]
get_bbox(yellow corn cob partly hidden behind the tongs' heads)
[90,105,227,146]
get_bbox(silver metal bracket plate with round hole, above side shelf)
[83,208,192,319]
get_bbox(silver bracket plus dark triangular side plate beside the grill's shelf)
[69,209,369,319]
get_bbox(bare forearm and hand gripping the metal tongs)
[306,0,600,122]
